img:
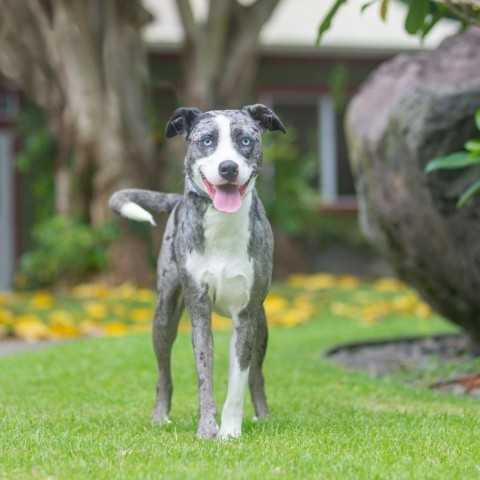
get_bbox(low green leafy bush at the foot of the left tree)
[17,215,117,288]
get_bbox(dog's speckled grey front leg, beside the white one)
[188,286,218,440]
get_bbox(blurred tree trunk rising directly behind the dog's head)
[177,0,279,110]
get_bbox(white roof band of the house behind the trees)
[143,0,458,50]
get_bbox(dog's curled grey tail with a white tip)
[108,189,182,225]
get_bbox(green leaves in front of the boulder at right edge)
[425,108,480,207]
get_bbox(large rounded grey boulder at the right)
[346,29,480,343]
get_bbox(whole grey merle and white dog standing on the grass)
[109,104,285,439]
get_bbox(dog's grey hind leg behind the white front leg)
[248,306,270,418]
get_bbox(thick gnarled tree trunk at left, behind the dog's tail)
[0,0,157,281]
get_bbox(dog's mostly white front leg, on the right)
[220,312,256,438]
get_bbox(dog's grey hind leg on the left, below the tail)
[152,221,184,423]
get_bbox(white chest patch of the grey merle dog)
[186,195,253,317]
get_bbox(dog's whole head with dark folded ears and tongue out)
[166,104,285,212]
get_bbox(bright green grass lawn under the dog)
[0,280,480,480]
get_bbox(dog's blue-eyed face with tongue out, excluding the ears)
[186,111,262,213]
